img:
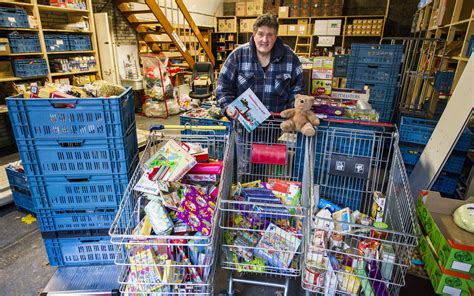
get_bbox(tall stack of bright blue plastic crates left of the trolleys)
[6,88,138,266]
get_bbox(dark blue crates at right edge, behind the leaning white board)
[400,116,473,197]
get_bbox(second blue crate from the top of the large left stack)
[17,129,138,177]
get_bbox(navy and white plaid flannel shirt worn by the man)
[216,37,303,114]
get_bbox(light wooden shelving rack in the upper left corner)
[0,0,100,83]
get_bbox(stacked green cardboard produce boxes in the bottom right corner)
[417,191,474,295]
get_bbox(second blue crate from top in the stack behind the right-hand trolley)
[347,62,400,87]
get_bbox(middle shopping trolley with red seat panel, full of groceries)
[219,119,314,295]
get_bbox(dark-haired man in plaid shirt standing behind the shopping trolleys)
[216,14,303,182]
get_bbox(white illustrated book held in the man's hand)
[227,88,270,133]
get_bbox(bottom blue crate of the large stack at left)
[44,236,115,266]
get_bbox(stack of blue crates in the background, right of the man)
[346,44,403,122]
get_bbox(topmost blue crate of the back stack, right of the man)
[349,44,403,66]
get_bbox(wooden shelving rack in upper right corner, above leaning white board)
[401,0,474,116]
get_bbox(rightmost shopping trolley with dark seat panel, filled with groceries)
[301,124,418,295]
